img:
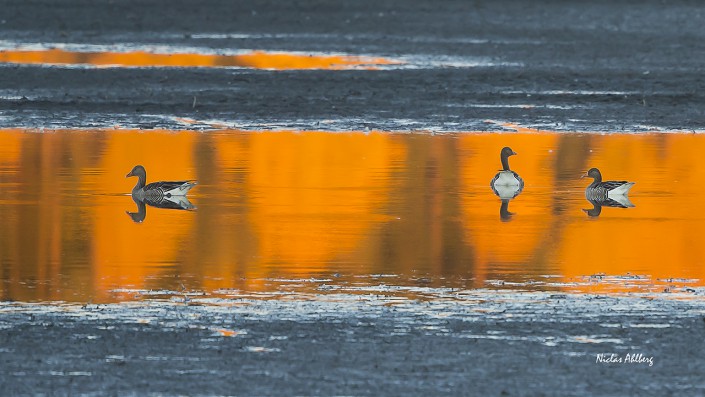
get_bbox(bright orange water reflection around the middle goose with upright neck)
[459,134,559,278]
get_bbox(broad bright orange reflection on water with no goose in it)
[241,132,405,276]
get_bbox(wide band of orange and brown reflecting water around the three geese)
[0,130,705,302]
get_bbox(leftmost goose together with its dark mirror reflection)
[125,165,197,223]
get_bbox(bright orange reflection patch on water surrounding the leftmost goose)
[91,130,196,291]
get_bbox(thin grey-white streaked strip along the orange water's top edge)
[0,111,705,134]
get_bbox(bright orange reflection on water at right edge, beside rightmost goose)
[556,134,705,288]
